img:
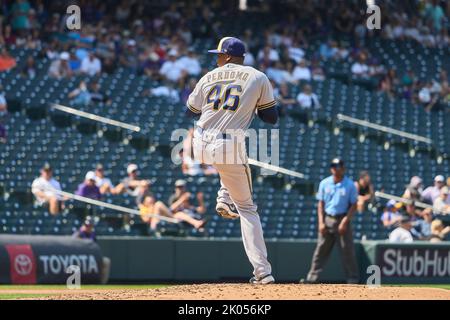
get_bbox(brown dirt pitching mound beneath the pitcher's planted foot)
[14,284,450,300]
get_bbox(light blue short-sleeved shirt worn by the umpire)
[316,176,358,216]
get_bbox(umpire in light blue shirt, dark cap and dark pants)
[306,158,359,284]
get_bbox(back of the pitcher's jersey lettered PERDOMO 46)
[187,63,276,133]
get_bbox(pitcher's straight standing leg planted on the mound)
[216,164,272,278]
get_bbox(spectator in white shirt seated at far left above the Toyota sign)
[31,164,63,215]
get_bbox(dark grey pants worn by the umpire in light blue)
[307,215,359,283]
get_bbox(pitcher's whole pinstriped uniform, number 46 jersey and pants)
[187,63,276,278]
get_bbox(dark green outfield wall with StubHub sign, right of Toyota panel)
[98,237,450,283]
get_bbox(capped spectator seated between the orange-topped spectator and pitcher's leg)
[169,180,206,218]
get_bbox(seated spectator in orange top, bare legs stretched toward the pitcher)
[139,194,206,231]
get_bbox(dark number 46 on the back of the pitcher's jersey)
[206,84,242,111]
